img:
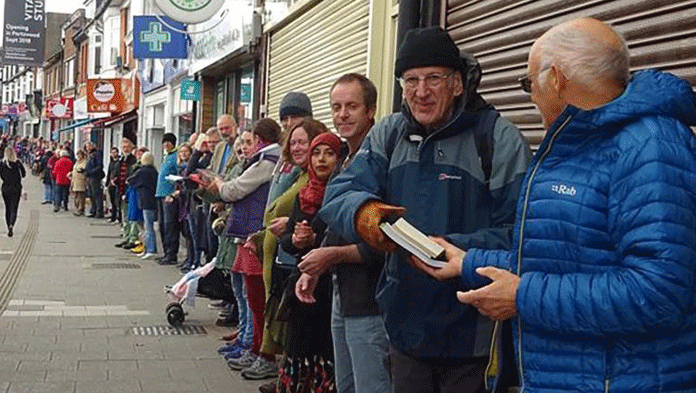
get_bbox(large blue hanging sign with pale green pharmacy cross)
[133,16,187,59]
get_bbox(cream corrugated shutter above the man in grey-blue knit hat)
[267,0,369,128]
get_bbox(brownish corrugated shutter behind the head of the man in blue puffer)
[445,0,696,145]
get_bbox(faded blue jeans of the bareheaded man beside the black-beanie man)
[331,278,391,393]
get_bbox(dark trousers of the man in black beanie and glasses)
[389,345,488,393]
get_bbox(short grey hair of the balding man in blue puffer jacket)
[539,26,630,87]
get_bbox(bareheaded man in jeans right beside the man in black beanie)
[295,73,391,393]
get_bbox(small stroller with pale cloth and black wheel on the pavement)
[164,260,235,326]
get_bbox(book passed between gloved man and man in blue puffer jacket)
[379,218,447,268]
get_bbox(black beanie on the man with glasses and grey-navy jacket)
[394,27,464,78]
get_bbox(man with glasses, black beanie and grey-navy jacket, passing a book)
[319,27,530,393]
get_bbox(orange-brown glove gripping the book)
[355,200,406,252]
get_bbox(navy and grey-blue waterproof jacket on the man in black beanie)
[319,98,530,359]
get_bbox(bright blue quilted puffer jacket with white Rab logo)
[462,71,696,393]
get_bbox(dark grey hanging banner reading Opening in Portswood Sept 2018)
[3,0,46,66]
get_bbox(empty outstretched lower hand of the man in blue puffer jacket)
[457,266,520,321]
